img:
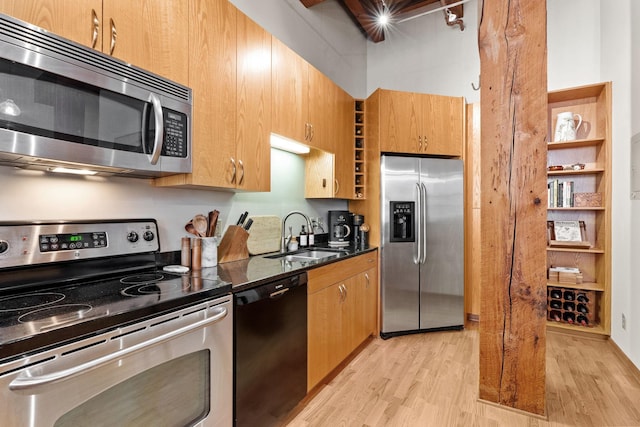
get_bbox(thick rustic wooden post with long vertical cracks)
[479,0,548,415]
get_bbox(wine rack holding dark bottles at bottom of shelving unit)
[547,286,599,328]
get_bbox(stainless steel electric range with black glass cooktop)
[0,219,233,426]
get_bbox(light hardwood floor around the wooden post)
[288,326,640,427]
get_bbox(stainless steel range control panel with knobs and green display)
[0,219,160,268]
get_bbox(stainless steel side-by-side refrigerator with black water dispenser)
[380,155,464,338]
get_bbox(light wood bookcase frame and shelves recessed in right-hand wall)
[547,82,613,337]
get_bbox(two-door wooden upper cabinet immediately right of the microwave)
[155,0,271,191]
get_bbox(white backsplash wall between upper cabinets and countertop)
[0,149,347,251]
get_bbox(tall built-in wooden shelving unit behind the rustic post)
[547,82,612,335]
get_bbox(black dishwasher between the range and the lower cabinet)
[234,273,307,427]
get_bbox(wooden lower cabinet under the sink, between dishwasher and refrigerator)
[307,251,378,390]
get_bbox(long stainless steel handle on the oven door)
[9,307,227,391]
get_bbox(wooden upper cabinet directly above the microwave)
[0,0,189,85]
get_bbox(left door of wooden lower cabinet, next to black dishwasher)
[307,283,343,390]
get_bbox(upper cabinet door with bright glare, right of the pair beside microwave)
[236,10,272,191]
